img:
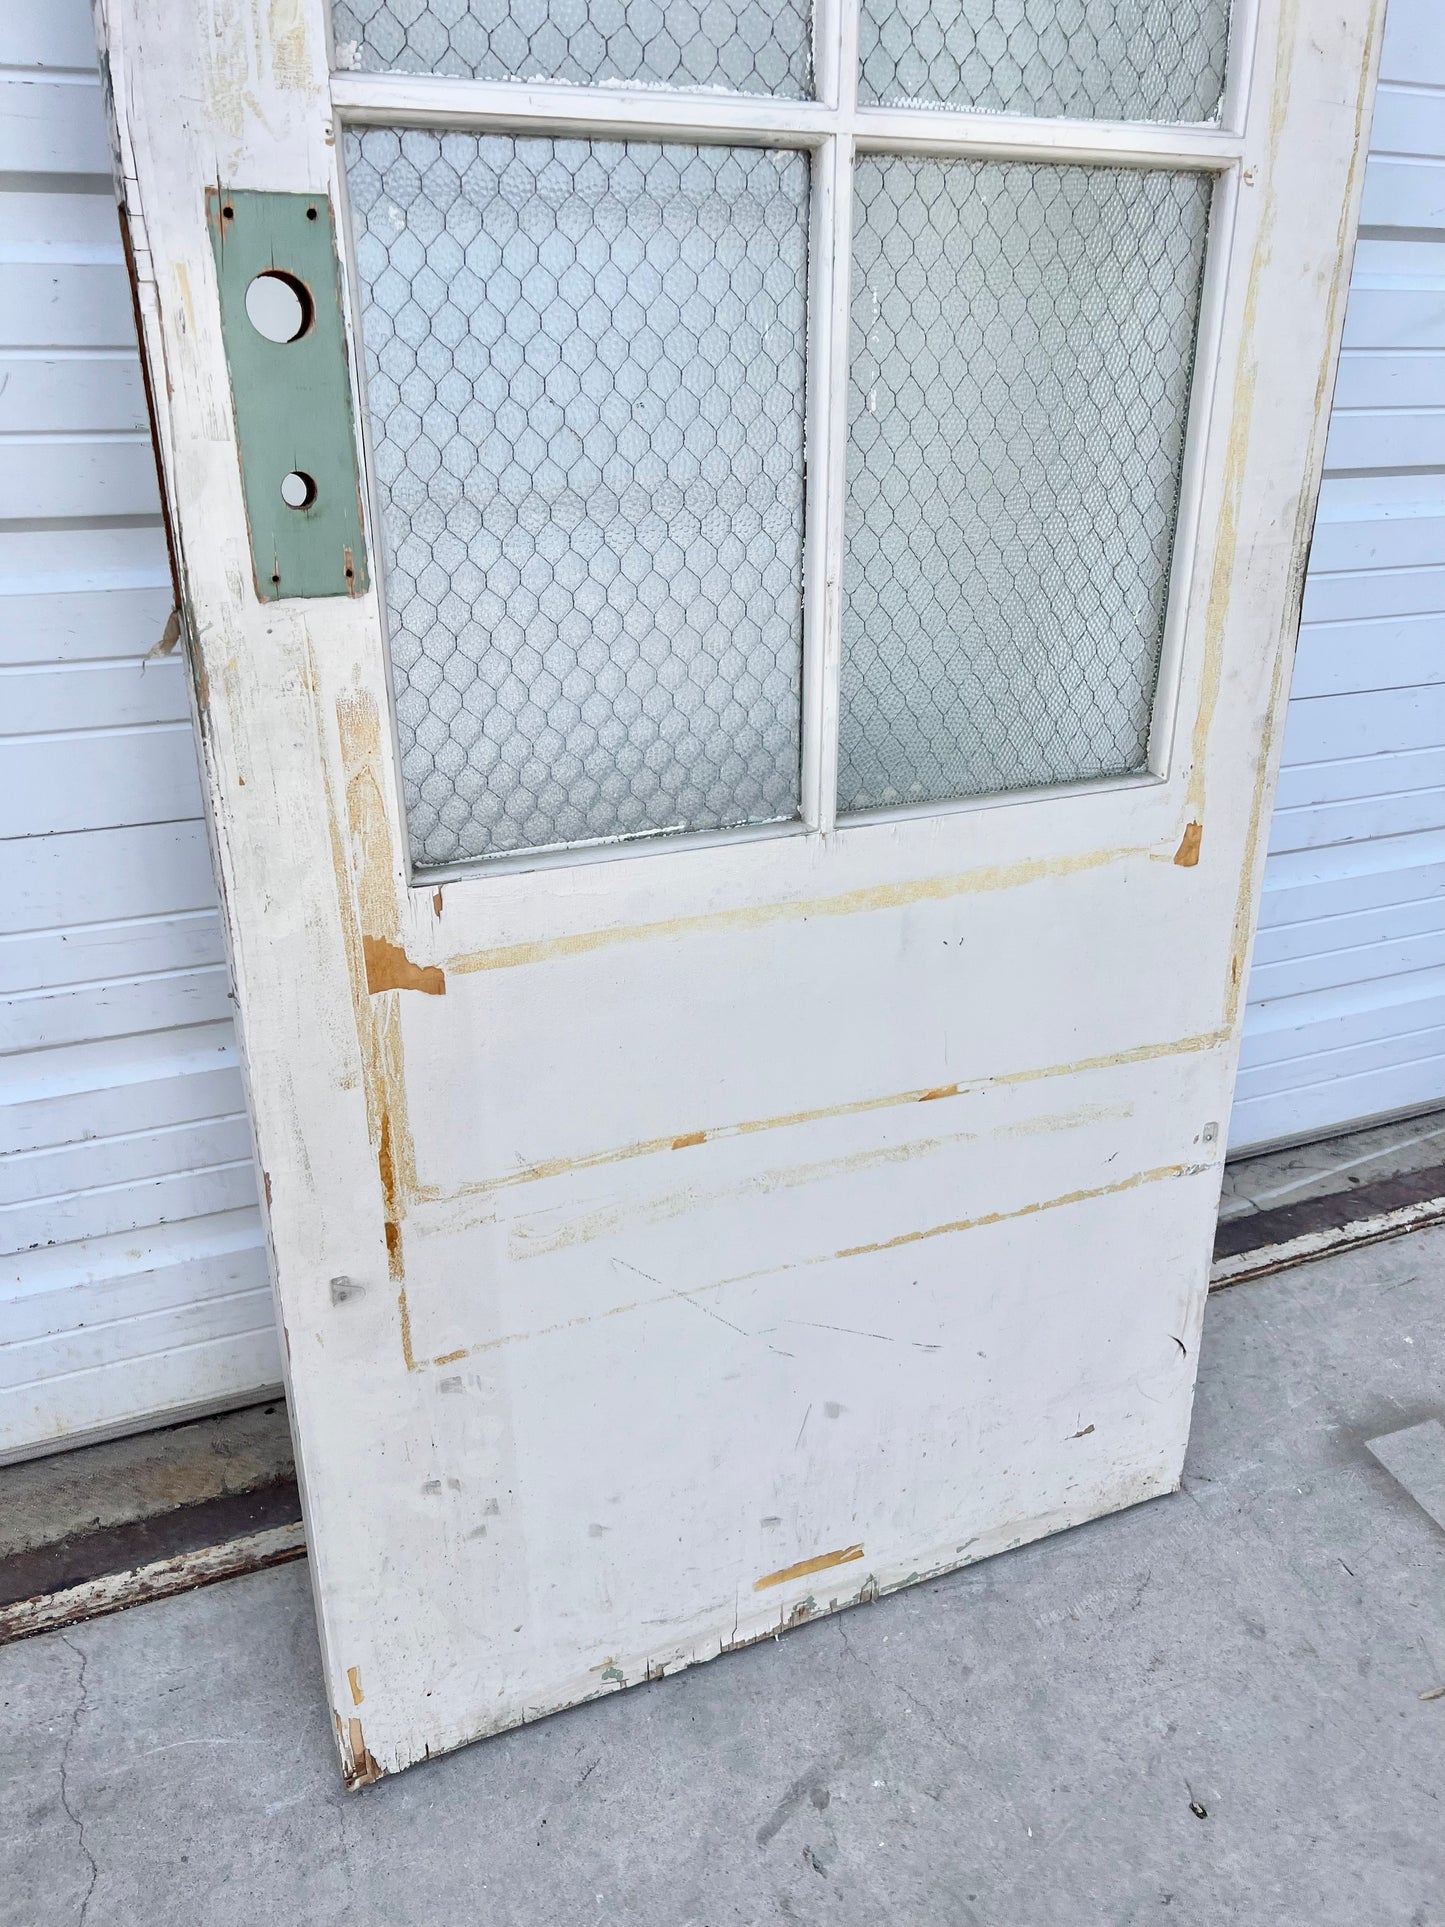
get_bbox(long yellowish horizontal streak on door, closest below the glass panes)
[447,848,1150,975]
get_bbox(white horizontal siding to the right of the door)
[1231,0,1445,1148]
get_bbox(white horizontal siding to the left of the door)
[0,0,279,1457]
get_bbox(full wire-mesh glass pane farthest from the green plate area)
[838,156,1210,811]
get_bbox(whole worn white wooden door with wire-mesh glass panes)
[102,0,1376,1779]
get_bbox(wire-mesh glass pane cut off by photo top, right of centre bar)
[857,0,1229,121]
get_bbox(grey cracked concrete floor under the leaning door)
[0,1227,1445,1927]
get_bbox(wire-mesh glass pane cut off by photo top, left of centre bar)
[331,0,813,100]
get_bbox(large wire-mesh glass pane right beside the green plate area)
[345,129,807,865]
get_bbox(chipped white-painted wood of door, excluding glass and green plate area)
[102,0,1378,1779]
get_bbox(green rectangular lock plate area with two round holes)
[206,187,368,601]
